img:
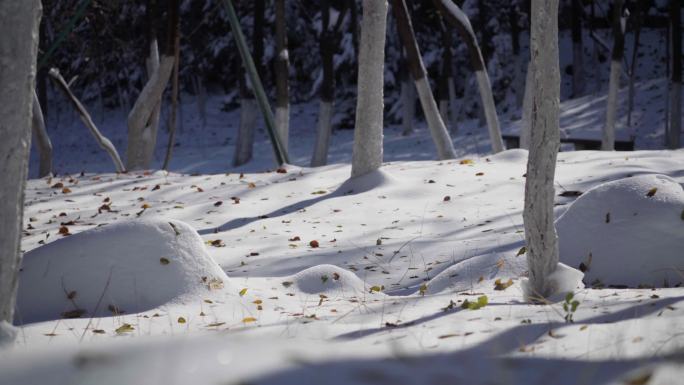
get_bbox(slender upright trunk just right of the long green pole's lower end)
[275,0,290,150]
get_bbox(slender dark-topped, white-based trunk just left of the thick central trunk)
[311,0,336,167]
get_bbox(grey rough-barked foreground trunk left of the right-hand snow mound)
[523,0,560,301]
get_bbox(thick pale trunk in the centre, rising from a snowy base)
[351,0,387,178]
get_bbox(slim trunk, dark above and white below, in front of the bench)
[601,0,626,151]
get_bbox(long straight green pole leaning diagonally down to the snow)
[223,0,290,164]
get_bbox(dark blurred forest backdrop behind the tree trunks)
[38,0,668,127]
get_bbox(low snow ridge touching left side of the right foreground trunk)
[416,252,527,294]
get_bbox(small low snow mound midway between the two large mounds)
[289,265,374,296]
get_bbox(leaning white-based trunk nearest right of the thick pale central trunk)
[392,0,456,159]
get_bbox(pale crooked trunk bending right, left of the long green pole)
[126,55,175,170]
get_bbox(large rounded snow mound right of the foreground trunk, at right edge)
[556,175,684,287]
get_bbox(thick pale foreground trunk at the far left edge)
[0,0,42,334]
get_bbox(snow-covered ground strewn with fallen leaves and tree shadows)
[5,79,684,385]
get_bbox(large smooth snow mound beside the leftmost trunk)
[15,219,228,324]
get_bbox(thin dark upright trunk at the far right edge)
[668,0,682,150]
